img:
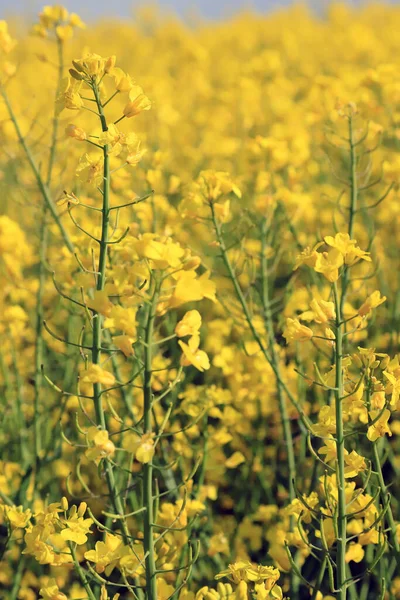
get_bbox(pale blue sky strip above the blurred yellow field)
[0,0,400,20]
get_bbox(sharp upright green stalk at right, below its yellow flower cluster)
[333,283,347,600]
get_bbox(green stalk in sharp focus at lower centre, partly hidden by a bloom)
[143,283,159,600]
